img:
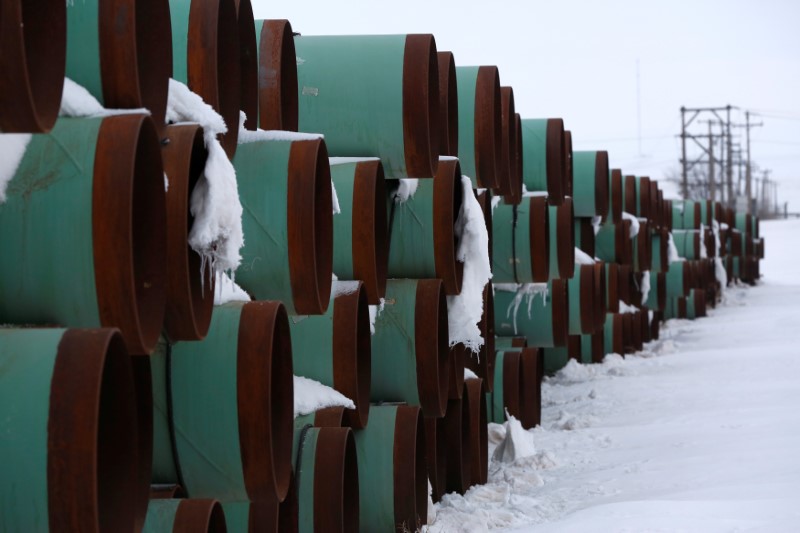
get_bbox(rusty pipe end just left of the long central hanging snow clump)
[433,159,464,295]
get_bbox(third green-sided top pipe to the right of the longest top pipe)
[572,150,609,219]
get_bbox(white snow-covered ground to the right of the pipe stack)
[428,220,800,533]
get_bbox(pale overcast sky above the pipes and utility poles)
[252,0,800,212]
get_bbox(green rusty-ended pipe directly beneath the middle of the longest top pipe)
[330,158,389,305]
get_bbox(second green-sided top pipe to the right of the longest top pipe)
[522,118,567,205]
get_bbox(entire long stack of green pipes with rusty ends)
[0,0,764,532]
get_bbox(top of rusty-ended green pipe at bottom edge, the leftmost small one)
[141,498,229,533]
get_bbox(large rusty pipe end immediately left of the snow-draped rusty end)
[92,115,167,355]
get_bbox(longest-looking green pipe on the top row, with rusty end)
[294,34,440,178]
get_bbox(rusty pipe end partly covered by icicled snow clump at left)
[162,124,215,342]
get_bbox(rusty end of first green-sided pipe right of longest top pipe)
[474,66,503,192]
